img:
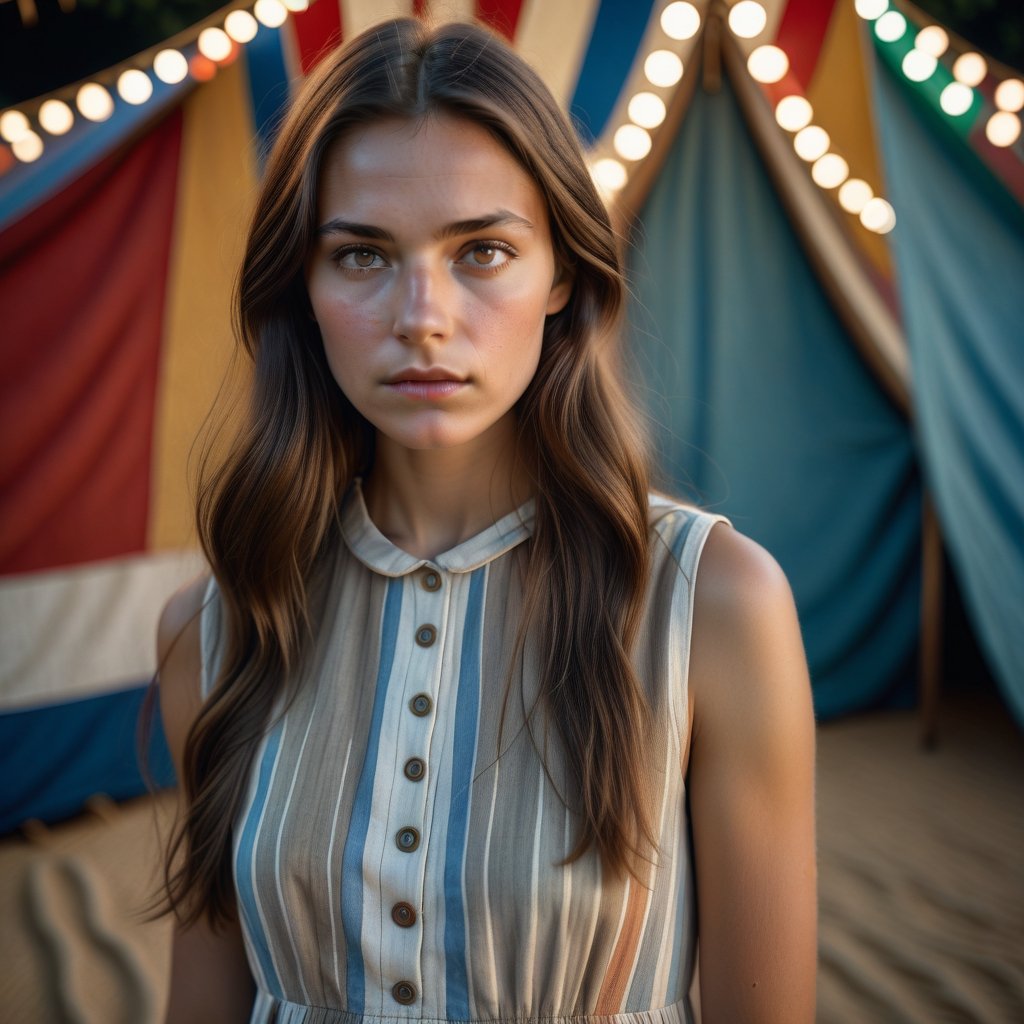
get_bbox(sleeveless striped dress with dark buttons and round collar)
[201,484,718,1024]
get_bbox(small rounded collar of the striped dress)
[341,478,534,577]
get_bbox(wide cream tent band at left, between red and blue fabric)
[0,551,206,711]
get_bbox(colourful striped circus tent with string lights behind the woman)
[0,0,1024,830]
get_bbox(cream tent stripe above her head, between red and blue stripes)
[515,0,600,110]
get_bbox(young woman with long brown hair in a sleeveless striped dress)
[159,20,815,1024]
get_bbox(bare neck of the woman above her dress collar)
[364,417,532,558]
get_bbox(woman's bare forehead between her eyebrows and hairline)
[317,115,547,223]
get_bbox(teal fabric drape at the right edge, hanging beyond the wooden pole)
[876,67,1024,724]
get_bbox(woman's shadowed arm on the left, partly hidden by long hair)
[157,579,255,1024]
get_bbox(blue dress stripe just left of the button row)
[341,578,402,1014]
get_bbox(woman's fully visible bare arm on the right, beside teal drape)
[689,527,817,1024]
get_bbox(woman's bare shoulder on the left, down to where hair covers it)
[157,575,209,769]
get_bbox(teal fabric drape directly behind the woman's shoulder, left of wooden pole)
[630,79,921,717]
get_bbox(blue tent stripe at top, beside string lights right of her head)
[569,0,653,145]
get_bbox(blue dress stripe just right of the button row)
[444,567,487,1020]
